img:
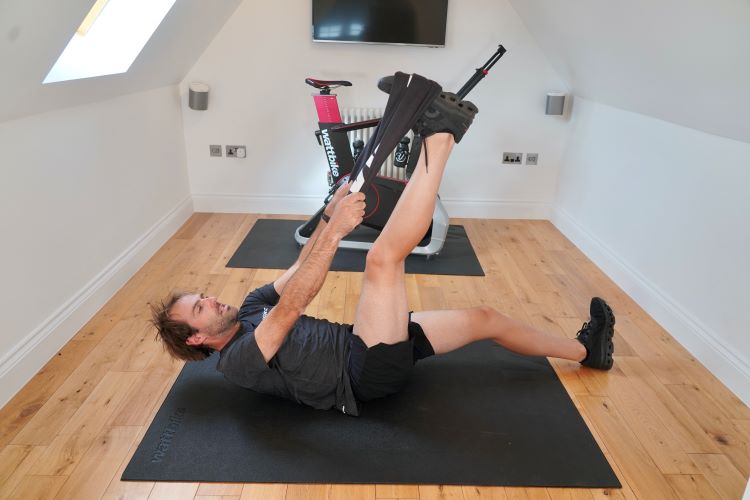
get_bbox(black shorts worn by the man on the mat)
[348,313,435,401]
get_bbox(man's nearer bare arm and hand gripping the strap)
[255,189,365,362]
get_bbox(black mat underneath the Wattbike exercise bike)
[227,219,484,276]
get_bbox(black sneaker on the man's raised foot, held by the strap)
[413,92,479,143]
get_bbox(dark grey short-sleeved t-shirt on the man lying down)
[216,283,359,416]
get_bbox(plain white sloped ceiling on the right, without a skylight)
[510,0,750,142]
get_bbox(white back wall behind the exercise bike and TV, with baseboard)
[181,0,567,218]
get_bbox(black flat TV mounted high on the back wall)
[312,0,448,47]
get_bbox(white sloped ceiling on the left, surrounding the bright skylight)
[0,0,242,122]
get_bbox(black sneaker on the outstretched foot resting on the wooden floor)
[576,297,615,370]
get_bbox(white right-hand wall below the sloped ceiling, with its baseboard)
[555,98,750,404]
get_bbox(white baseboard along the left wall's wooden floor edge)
[0,197,193,407]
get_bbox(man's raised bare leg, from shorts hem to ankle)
[354,133,454,347]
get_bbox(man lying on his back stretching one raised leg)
[152,75,615,415]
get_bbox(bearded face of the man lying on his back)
[169,293,238,337]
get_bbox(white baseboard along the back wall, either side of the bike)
[193,194,552,220]
